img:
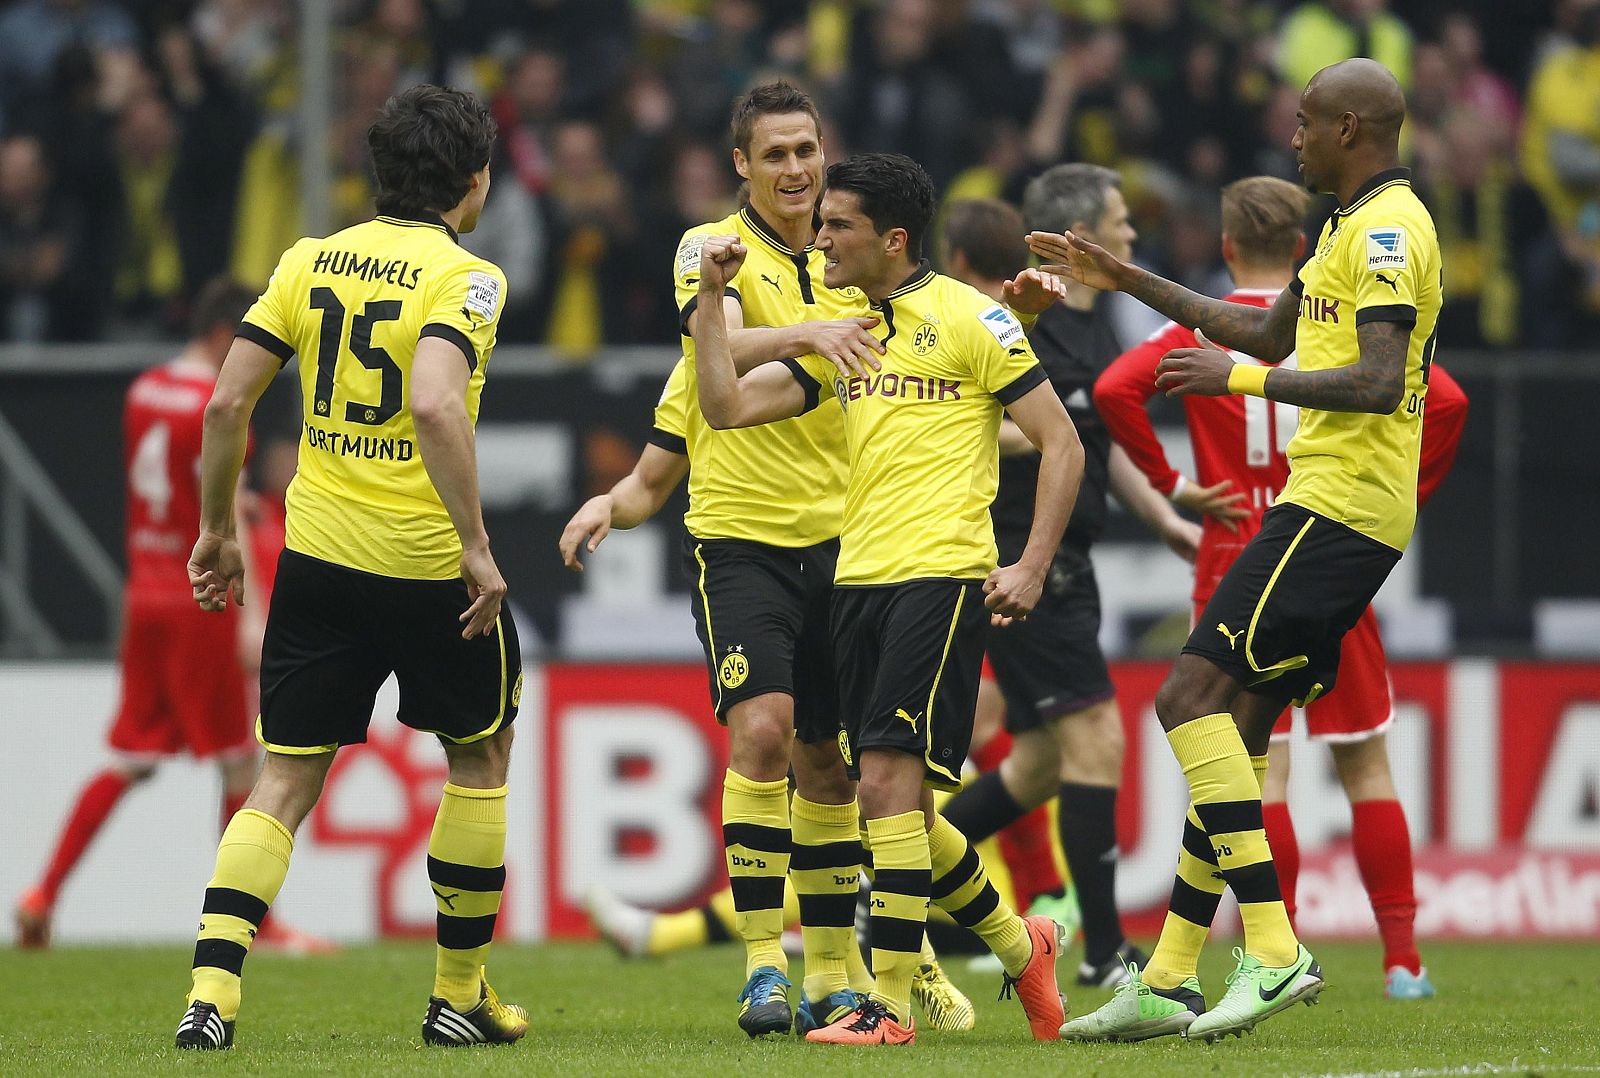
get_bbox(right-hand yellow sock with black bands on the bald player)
[1166,713,1299,966]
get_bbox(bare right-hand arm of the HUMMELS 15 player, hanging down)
[411,337,506,640]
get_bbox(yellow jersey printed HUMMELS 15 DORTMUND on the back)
[238,216,506,581]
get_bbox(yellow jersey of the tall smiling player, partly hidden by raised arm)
[674,208,867,547]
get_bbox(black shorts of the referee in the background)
[989,547,1117,734]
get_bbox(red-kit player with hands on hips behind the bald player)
[1094,176,1467,998]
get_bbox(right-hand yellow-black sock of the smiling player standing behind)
[789,793,861,1001]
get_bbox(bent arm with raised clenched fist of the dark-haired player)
[693,235,806,430]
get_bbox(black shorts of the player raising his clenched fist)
[834,579,989,790]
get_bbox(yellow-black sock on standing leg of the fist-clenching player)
[867,809,933,1025]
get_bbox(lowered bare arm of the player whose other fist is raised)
[984,382,1083,625]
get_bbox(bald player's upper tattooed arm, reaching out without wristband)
[1027,232,1299,363]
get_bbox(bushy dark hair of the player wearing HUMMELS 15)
[366,85,496,216]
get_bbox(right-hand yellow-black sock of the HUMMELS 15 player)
[427,782,506,1012]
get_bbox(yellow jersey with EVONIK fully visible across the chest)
[789,262,1046,587]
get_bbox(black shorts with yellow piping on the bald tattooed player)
[1184,502,1400,704]
